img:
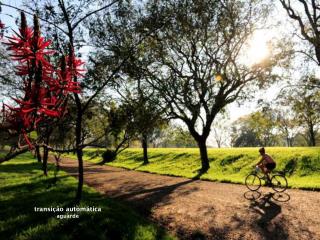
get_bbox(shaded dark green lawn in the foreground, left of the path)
[0,153,173,240]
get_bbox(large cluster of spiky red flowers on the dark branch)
[2,12,83,149]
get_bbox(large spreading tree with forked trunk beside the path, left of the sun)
[136,0,276,172]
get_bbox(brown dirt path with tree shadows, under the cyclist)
[56,159,320,240]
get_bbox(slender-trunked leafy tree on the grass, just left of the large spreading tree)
[88,1,175,164]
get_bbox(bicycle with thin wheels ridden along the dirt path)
[245,167,288,192]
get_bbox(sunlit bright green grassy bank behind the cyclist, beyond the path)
[71,147,320,189]
